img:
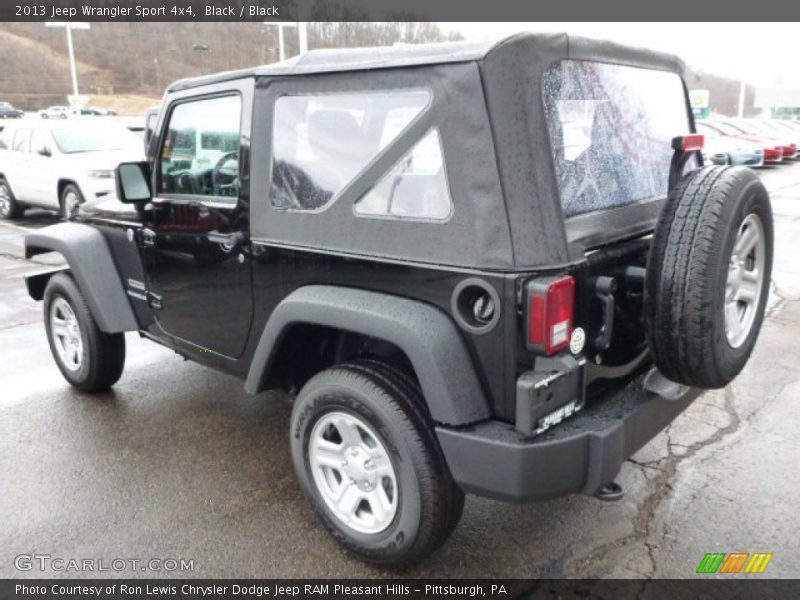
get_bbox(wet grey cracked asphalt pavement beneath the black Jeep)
[0,163,800,578]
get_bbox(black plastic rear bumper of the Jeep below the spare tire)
[436,375,703,502]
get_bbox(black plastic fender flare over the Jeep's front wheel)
[25,223,139,333]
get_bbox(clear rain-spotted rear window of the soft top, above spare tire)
[543,60,690,217]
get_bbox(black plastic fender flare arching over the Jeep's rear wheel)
[245,285,491,425]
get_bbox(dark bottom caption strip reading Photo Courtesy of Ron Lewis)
[0,578,800,600]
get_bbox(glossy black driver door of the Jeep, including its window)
[140,80,253,358]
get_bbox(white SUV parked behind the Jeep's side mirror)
[0,120,144,219]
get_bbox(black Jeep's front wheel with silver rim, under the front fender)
[44,273,125,392]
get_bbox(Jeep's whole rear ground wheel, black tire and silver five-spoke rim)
[291,361,464,566]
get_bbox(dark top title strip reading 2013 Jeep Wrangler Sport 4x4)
[0,0,800,22]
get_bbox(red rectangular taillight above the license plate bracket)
[525,276,575,355]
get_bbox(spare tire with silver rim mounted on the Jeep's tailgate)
[644,167,773,388]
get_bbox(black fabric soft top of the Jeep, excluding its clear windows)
[170,33,691,270]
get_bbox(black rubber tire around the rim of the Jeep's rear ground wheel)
[291,361,464,567]
